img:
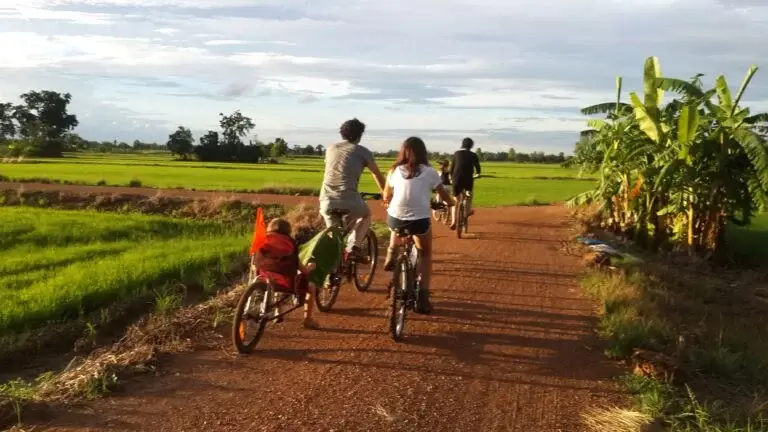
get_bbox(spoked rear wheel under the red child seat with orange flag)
[232,279,270,354]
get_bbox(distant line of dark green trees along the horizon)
[0,90,568,164]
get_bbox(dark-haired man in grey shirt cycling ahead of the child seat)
[320,118,384,258]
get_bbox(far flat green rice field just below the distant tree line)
[0,154,593,207]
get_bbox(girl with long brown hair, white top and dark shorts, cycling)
[383,137,453,313]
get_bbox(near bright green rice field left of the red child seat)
[0,207,250,334]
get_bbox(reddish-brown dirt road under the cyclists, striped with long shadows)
[0,185,624,432]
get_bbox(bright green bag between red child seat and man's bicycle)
[299,227,344,286]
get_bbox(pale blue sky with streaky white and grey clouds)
[0,0,768,153]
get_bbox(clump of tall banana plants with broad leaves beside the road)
[572,57,768,251]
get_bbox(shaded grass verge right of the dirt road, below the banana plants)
[582,259,768,432]
